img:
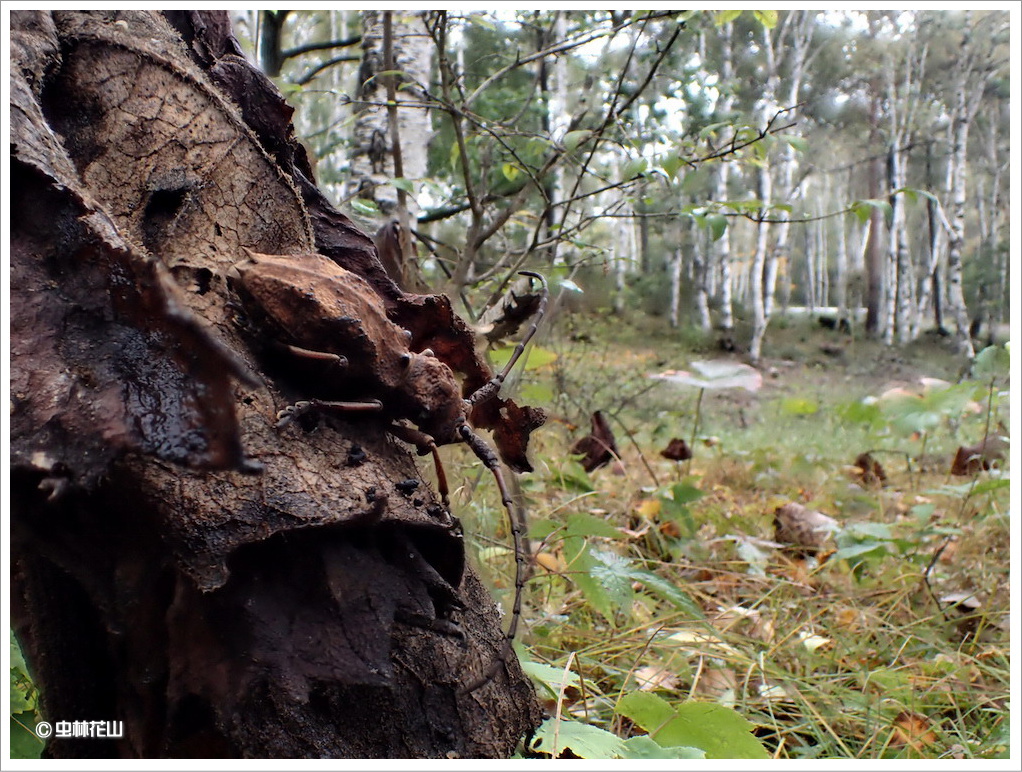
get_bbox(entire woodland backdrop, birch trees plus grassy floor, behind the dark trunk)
[11,10,1018,759]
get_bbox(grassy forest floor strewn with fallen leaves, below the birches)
[457,314,1010,759]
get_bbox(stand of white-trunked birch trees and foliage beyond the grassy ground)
[237,10,1009,361]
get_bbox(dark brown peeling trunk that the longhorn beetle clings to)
[10,11,541,758]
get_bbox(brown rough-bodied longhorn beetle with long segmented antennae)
[230,249,549,692]
